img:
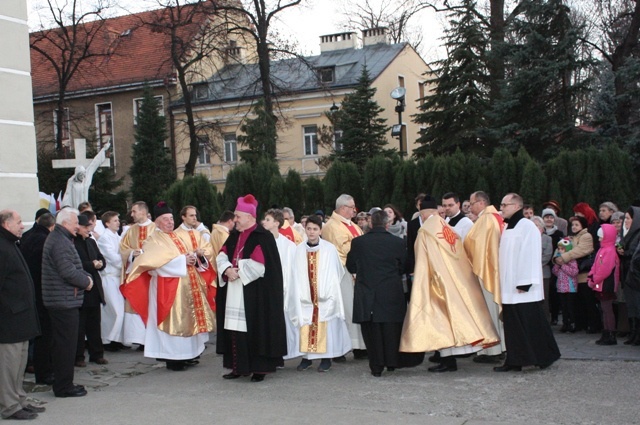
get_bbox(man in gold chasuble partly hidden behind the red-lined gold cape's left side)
[120,201,156,350]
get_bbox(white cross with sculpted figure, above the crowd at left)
[53,139,111,208]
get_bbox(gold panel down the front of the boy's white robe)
[300,251,327,353]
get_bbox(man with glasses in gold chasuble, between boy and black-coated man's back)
[322,194,364,362]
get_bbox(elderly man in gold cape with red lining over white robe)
[121,202,215,371]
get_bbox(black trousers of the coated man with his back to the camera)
[360,322,402,373]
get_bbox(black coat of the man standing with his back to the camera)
[347,227,407,323]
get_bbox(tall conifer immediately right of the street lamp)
[414,0,489,157]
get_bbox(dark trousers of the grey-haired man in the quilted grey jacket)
[49,308,80,393]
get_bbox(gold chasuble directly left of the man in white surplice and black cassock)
[464,205,504,308]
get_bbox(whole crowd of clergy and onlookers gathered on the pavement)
[0,191,640,419]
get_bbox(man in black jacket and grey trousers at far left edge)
[0,210,44,419]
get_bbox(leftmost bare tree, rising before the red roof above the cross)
[30,0,113,151]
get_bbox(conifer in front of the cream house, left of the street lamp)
[327,65,389,172]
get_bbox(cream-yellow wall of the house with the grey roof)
[175,43,428,189]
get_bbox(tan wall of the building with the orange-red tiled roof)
[34,88,175,190]
